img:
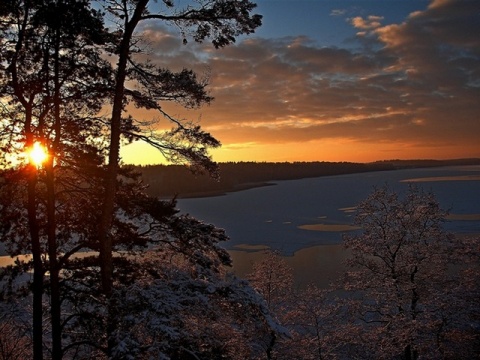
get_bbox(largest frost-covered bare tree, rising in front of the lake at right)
[343,187,479,360]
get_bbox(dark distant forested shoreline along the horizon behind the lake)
[134,159,480,198]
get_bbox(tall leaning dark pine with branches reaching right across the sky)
[94,0,261,354]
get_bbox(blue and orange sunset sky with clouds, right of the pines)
[121,0,480,164]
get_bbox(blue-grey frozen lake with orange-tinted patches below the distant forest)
[178,166,480,283]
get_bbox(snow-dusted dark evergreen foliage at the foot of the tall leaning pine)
[58,200,283,359]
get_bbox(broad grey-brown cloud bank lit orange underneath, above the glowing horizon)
[129,0,480,160]
